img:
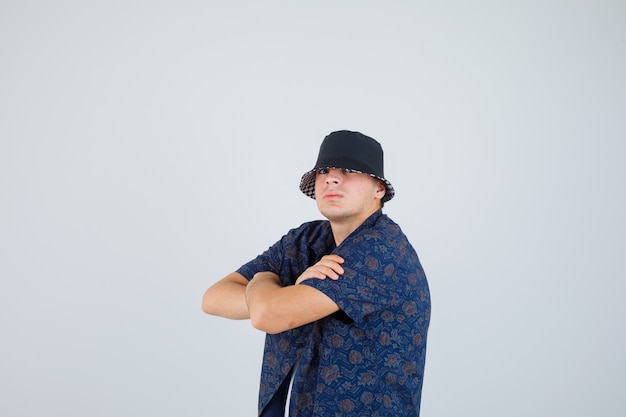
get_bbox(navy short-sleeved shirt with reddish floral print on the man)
[238,210,430,417]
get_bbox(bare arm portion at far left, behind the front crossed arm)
[202,272,250,320]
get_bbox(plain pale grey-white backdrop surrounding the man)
[0,0,626,417]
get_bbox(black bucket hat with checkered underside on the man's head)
[300,130,396,203]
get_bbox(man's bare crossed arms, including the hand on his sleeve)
[202,255,343,333]
